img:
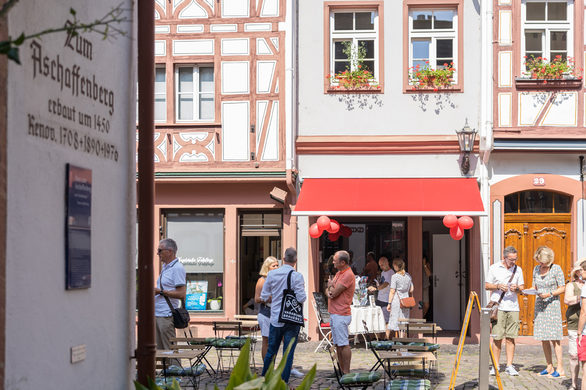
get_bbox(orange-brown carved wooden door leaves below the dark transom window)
[504,214,572,336]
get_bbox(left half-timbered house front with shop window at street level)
[149,0,296,333]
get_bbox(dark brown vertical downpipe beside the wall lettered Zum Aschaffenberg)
[136,0,156,386]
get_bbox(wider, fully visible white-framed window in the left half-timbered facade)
[175,65,215,122]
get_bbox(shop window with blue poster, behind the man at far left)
[163,210,225,311]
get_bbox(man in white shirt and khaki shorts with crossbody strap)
[485,246,525,376]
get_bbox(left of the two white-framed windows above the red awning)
[330,9,379,79]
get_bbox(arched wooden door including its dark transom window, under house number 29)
[502,190,572,336]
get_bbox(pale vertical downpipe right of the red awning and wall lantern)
[478,0,493,306]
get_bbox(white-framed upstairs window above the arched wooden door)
[521,0,574,61]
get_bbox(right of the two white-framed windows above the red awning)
[409,8,458,82]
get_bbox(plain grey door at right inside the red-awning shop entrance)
[432,234,462,330]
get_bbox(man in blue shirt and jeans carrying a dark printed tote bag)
[260,248,307,382]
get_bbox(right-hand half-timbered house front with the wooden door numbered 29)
[490,0,586,335]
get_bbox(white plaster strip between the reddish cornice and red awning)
[298,154,478,179]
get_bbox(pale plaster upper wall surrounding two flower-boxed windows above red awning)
[298,1,481,135]
